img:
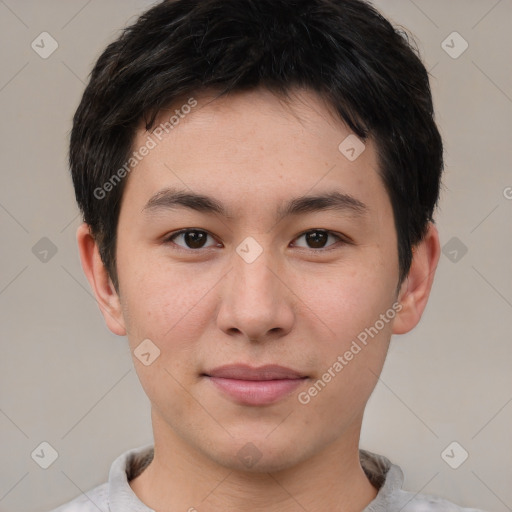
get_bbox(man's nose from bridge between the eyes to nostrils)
[217,241,295,342]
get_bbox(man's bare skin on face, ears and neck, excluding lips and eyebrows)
[77,90,440,512]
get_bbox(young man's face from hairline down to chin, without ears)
[109,87,400,471]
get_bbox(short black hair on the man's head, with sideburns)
[69,0,443,290]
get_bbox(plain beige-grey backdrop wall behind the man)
[0,0,512,512]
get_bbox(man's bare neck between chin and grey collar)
[130,414,377,512]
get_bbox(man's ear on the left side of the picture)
[76,223,126,336]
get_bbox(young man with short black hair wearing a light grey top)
[53,0,488,512]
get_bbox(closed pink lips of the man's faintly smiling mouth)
[203,365,308,405]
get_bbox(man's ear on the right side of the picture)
[393,223,441,334]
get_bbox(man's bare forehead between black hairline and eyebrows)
[125,89,387,218]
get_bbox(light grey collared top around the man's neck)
[52,444,483,512]
